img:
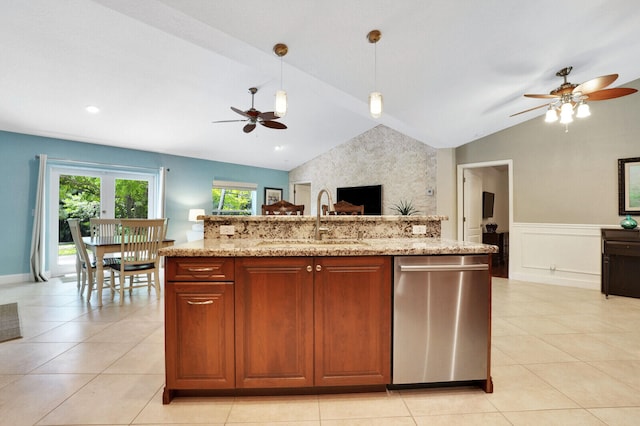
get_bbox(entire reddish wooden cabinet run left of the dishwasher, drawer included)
[163,256,392,403]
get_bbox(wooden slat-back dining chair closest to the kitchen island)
[109,219,165,305]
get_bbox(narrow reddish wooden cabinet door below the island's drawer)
[165,282,235,389]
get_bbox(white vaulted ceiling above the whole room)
[0,0,640,170]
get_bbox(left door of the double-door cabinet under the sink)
[235,257,313,388]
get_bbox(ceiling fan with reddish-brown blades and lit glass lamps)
[510,67,637,124]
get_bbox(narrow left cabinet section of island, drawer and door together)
[163,258,235,404]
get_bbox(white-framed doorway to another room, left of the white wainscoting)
[457,160,513,277]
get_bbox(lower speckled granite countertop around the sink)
[160,238,498,257]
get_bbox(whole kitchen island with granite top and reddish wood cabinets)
[161,216,496,403]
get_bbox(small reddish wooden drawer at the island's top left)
[165,257,234,281]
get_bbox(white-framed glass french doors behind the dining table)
[47,166,159,276]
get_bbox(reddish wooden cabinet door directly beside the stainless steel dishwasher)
[314,256,391,386]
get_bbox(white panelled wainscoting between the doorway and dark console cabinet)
[509,223,610,290]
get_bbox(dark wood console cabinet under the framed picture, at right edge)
[601,228,640,297]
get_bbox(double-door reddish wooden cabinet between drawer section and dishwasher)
[236,256,391,387]
